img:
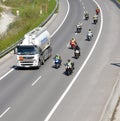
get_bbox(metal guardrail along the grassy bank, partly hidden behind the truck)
[0,0,59,58]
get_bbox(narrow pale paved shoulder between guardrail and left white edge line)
[0,0,68,79]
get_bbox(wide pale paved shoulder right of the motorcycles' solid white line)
[47,1,120,121]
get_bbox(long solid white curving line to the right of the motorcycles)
[44,0,103,121]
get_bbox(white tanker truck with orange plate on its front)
[16,27,52,68]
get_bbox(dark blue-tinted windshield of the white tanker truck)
[17,46,38,55]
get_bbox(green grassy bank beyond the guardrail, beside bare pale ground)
[0,0,56,52]
